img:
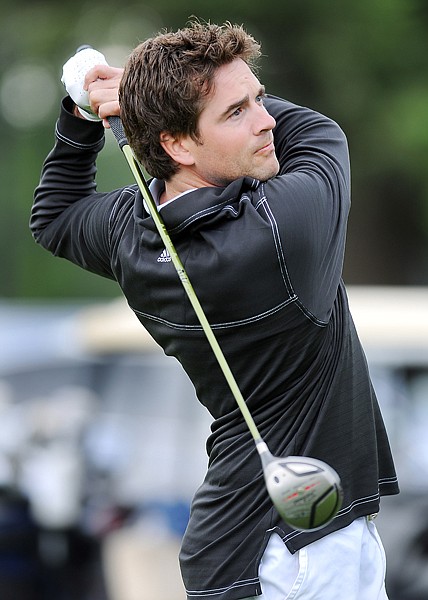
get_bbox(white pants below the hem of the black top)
[247,517,388,600]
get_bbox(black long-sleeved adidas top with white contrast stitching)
[31,97,398,600]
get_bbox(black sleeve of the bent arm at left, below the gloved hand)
[30,98,128,279]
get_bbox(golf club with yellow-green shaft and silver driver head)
[65,46,343,531]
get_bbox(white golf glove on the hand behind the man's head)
[61,48,108,121]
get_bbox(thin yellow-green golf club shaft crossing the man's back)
[108,117,268,456]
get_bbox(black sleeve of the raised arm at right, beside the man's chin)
[264,97,351,321]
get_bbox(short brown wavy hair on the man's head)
[119,21,261,180]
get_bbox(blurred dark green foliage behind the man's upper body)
[0,0,428,298]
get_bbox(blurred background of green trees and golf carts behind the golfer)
[0,0,428,600]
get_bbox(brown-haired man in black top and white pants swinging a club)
[31,23,398,600]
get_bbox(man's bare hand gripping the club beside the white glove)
[83,65,123,128]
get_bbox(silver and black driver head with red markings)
[263,453,343,531]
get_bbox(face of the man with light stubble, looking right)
[181,59,279,187]
